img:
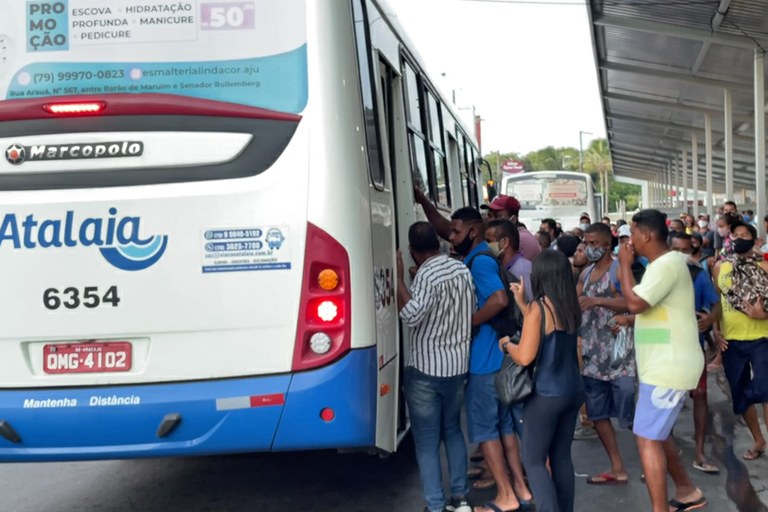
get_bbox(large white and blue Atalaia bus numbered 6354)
[0,0,480,461]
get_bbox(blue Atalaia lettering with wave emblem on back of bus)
[0,208,168,271]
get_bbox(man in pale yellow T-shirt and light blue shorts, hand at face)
[619,210,707,512]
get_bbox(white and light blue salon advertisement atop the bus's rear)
[0,0,307,113]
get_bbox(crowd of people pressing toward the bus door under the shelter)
[397,189,768,512]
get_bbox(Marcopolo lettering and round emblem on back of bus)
[5,141,144,165]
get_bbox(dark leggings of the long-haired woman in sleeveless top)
[522,394,584,512]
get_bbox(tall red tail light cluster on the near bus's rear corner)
[293,224,351,371]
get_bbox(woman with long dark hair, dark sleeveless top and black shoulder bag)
[499,251,584,512]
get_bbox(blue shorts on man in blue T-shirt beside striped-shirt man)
[465,373,515,443]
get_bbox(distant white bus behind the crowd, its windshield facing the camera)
[501,171,602,231]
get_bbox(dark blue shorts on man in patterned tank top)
[584,377,635,429]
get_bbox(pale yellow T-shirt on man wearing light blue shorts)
[634,251,704,390]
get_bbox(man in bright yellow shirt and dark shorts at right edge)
[713,222,768,460]
